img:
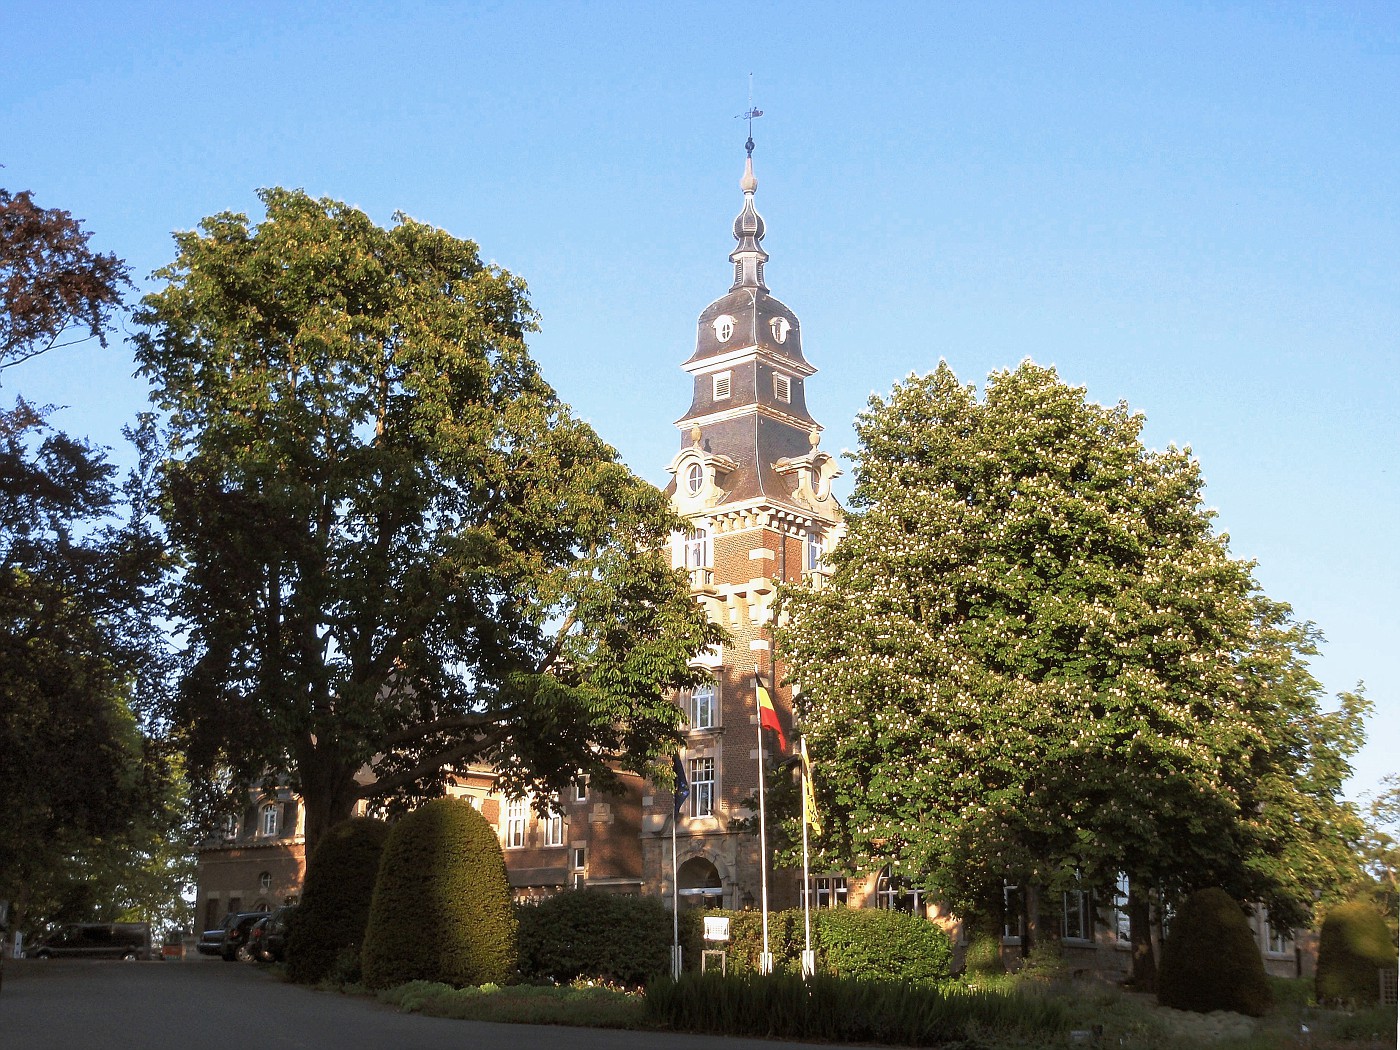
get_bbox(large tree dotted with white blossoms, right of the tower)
[780,361,1366,977]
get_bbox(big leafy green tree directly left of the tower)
[136,189,718,844]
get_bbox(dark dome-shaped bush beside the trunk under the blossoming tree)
[1156,889,1273,1018]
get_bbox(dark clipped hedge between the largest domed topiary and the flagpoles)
[515,889,672,987]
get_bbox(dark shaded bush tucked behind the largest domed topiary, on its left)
[287,816,389,984]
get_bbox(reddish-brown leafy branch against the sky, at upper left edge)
[0,189,130,370]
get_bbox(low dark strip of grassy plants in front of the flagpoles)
[647,973,1067,1046]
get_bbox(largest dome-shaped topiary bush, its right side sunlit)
[361,798,517,988]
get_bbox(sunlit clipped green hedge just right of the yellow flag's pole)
[813,907,953,981]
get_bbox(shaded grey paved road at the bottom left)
[0,959,830,1050]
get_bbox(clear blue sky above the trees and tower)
[0,0,1400,794]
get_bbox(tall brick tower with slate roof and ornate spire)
[643,139,843,909]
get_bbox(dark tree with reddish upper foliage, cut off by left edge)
[0,189,180,927]
